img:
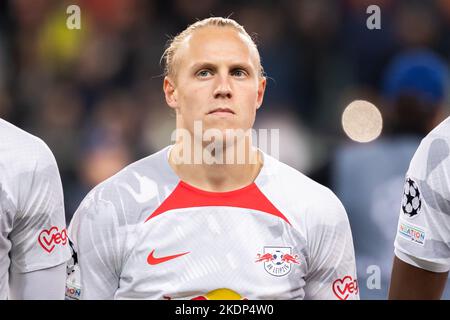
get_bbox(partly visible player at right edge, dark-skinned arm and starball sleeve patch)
[389,118,450,299]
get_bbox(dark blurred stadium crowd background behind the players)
[0,0,450,299]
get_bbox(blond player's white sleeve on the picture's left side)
[66,185,126,300]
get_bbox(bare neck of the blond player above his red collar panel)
[169,138,263,192]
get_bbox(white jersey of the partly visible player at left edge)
[0,119,70,299]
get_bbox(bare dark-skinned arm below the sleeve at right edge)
[389,257,448,300]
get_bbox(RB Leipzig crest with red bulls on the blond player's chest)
[255,247,300,277]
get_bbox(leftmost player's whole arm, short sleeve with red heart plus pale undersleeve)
[9,141,70,299]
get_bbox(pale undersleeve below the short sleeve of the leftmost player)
[8,263,66,300]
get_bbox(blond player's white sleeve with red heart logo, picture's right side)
[305,191,359,300]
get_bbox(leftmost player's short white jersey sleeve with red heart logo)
[9,140,70,273]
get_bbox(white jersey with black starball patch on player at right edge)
[395,118,450,272]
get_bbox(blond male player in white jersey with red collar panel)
[68,18,359,300]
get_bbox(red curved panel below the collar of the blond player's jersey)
[145,181,291,224]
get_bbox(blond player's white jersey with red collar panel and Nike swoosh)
[67,147,359,300]
